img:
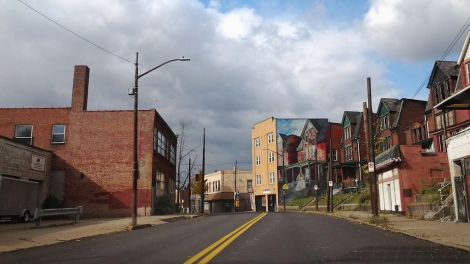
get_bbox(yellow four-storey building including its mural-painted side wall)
[251,117,342,211]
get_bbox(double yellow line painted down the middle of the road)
[184,213,267,264]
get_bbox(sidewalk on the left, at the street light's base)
[0,215,196,253]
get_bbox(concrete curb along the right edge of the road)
[302,211,470,252]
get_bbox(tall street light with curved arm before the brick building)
[129,52,189,226]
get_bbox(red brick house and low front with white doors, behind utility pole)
[374,98,449,213]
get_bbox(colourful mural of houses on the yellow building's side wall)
[276,119,328,203]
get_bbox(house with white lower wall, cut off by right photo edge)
[436,32,470,222]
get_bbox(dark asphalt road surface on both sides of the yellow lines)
[0,213,470,263]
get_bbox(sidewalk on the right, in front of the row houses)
[309,211,470,252]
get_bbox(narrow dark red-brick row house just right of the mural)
[340,111,367,188]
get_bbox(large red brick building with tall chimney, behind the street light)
[0,65,176,216]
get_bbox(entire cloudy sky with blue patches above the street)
[0,0,470,171]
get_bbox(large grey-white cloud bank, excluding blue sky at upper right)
[0,0,436,171]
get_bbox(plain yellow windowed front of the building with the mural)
[251,117,282,212]
